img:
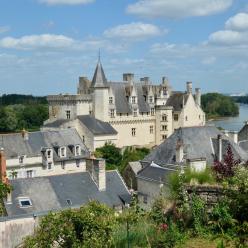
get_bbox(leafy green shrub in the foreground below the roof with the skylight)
[23,202,115,248]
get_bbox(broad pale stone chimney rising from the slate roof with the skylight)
[86,158,106,191]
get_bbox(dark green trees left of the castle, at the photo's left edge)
[0,95,48,133]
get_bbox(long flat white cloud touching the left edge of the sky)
[0,34,75,50]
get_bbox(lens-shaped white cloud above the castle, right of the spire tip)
[104,22,165,40]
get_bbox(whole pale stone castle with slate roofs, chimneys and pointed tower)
[43,60,205,151]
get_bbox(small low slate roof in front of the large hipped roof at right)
[137,165,176,183]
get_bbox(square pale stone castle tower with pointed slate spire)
[91,57,109,121]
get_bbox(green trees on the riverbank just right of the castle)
[202,93,239,118]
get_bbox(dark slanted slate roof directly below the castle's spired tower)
[77,115,117,135]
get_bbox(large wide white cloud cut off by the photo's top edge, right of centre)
[127,0,233,18]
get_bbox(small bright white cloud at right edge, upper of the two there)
[225,13,248,31]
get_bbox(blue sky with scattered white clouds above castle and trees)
[0,0,248,95]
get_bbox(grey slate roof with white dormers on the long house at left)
[0,128,88,159]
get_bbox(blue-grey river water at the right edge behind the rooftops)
[207,104,248,131]
